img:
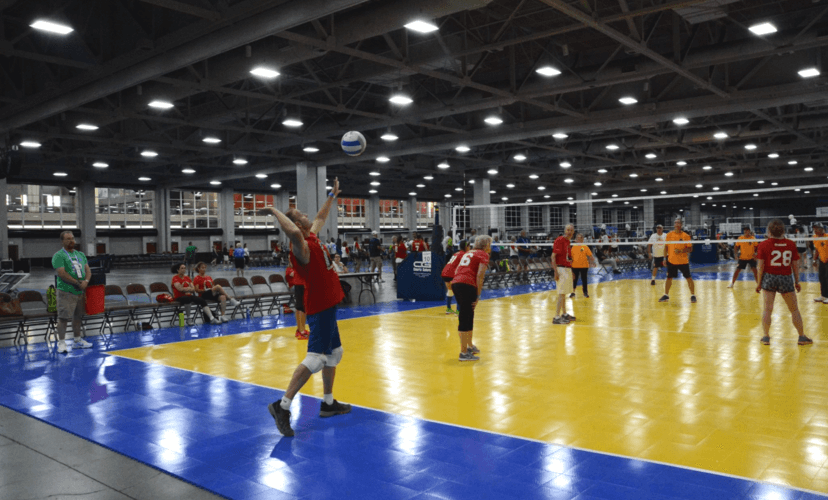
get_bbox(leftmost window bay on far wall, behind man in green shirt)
[6,184,78,229]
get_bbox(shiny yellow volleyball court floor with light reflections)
[115,280,828,492]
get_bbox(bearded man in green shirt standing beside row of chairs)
[52,231,92,353]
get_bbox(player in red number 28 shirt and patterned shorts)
[756,219,813,345]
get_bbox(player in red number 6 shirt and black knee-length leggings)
[451,236,492,361]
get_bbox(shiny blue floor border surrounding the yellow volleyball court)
[0,270,825,500]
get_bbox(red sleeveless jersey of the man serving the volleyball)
[290,233,345,316]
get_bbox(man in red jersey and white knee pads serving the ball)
[259,179,351,437]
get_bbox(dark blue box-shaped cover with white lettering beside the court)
[397,251,446,300]
